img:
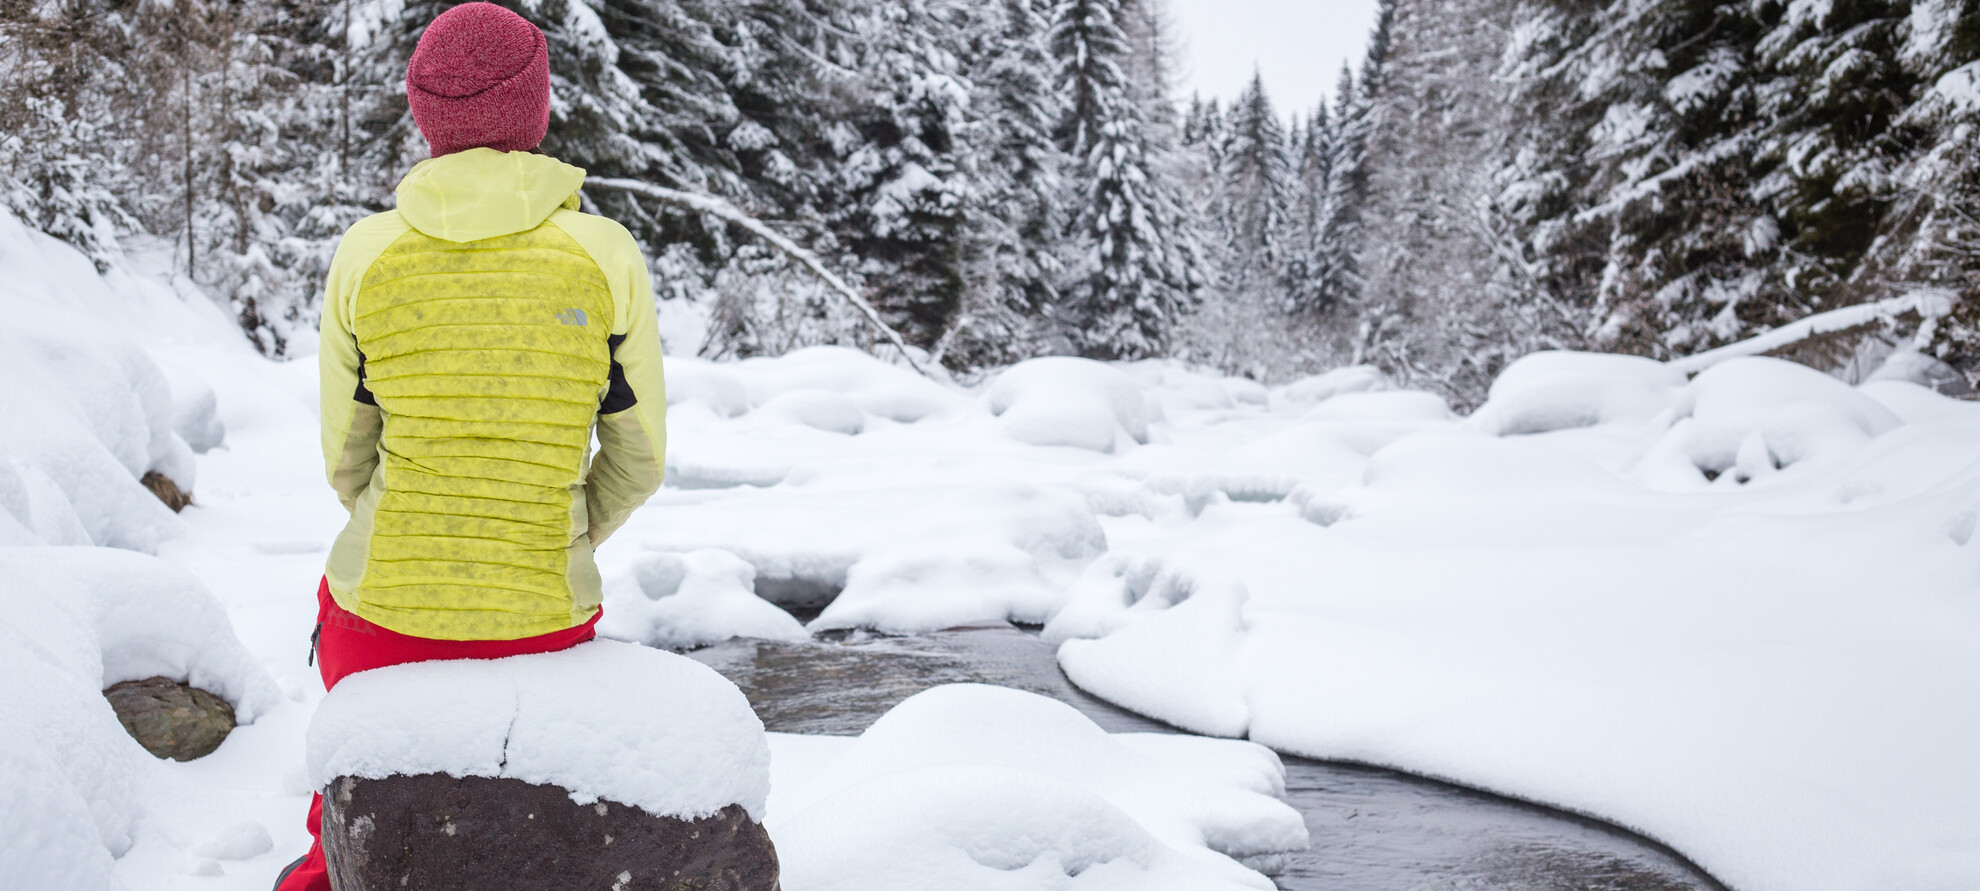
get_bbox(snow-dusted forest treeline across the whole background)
[0,0,1980,402]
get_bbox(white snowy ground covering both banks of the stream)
[0,208,1980,891]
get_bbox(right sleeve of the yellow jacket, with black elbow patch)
[584,218,667,546]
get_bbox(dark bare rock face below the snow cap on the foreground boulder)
[323,774,778,891]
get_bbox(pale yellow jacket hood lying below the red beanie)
[398,149,584,242]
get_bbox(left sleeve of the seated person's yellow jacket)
[317,214,404,511]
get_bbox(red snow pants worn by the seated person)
[275,578,600,891]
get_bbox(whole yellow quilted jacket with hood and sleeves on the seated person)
[321,149,667,640]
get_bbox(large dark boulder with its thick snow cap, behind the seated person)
[309,642,778,891]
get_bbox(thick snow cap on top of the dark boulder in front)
[309,642,770,820]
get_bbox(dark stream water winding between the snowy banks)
[689,626,1725,891]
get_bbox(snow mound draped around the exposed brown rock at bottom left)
[0,548,279,887]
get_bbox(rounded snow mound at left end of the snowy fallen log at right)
[1469,352,1685,436]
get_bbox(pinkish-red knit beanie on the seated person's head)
[406,2,550,158]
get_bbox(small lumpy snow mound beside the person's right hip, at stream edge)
[600,550,810,649]
